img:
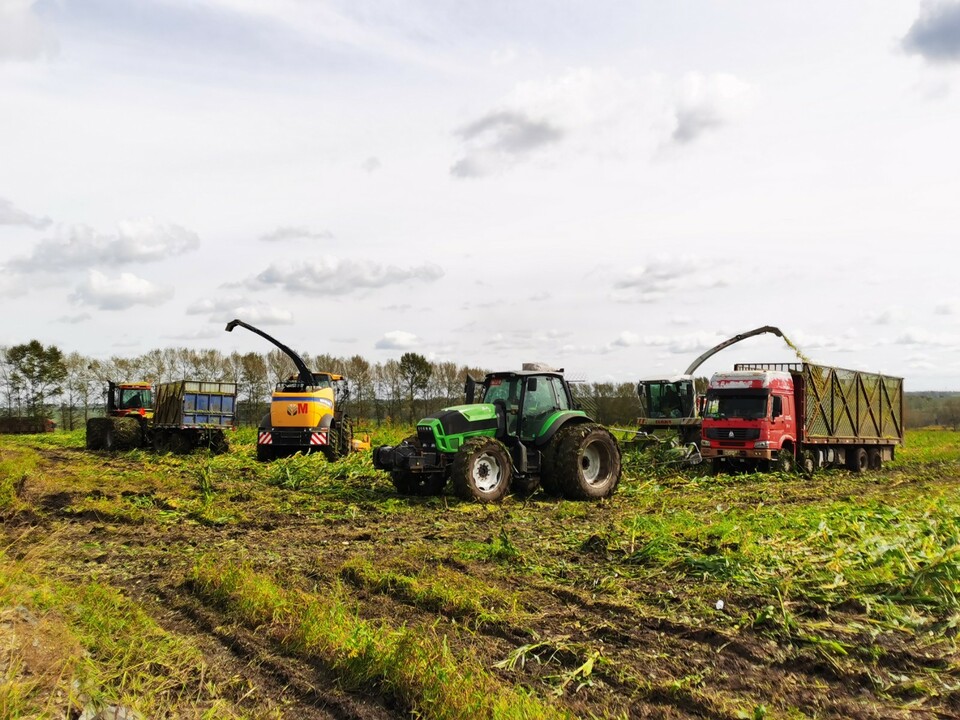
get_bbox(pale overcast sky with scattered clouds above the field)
[0,0,960,390]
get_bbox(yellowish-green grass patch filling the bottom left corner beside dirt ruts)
[0,553,238,718]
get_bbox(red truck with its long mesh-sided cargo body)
[700,362,903,472]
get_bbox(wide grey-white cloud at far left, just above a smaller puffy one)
[8,219,200,272]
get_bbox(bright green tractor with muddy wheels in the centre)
[373,365,620,502]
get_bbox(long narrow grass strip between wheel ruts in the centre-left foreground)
[192,558,567,720]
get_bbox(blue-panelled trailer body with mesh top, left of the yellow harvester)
[153,380,237,429]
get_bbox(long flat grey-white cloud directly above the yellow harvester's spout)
[246,256,443,296]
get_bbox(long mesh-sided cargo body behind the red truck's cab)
[735,363,903,445]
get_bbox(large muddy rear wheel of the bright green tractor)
[554,423,620,500]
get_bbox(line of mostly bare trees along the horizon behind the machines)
[0,340,640,429]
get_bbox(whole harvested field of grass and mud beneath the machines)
[0,427,960,719]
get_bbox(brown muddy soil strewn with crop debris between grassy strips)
[2,450,960,720]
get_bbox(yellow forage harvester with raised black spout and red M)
[226,320,357,460]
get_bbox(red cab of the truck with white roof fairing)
[700,370,798,471]
